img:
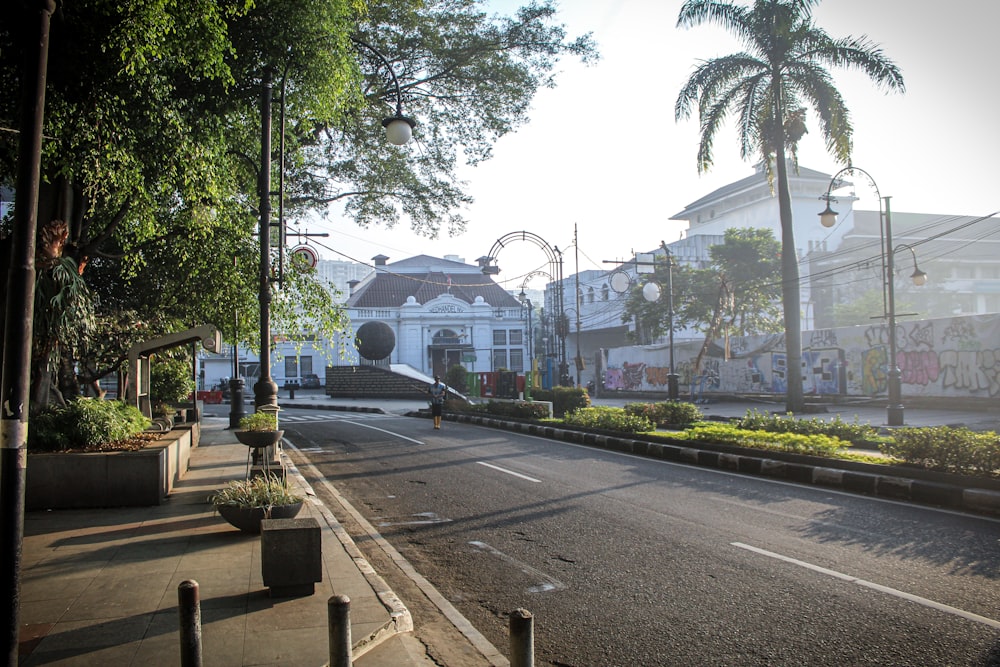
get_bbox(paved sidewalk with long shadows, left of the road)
[19,417,444,667]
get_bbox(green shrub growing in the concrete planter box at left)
[28,398,149,452]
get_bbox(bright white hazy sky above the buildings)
[300,0,1000,290]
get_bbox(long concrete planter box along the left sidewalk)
[25,423,200,510]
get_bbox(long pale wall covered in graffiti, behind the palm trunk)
[604,315,1000,398]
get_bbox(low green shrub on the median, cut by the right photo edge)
[880,426,1000,476]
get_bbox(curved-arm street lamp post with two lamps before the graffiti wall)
[819,166,927,426]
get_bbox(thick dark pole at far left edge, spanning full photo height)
[0,0,55,667]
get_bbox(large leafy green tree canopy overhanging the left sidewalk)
[0,0,596,408]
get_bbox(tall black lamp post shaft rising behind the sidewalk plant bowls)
[254,71,278,409]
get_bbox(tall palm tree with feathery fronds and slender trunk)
[674,0,904,412]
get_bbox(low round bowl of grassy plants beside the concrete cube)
[208,475,302,535]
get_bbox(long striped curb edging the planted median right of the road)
[445,413,1000,516]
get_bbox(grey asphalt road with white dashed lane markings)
[282,410,1000,667]
